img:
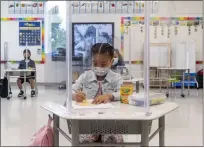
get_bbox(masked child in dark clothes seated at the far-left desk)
[17,49,35,97]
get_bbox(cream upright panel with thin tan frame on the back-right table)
[149,43,171,68]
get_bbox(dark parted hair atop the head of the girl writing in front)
[91,43,114,58]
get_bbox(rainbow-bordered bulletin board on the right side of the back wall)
[121,17,203,64]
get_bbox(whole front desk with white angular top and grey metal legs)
[41,101,179,147]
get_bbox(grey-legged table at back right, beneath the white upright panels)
[157,67,190,97]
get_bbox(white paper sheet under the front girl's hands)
[72,100,114,109]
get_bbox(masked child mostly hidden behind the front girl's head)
[111,49,125,72]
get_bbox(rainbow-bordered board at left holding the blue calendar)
[1,18,45,64]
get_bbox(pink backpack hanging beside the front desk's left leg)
[28,116,54,147]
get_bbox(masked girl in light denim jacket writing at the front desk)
[72,43,123,143]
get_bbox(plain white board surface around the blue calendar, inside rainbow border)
[1,20,42,61]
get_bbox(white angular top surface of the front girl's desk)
[41,102,179,120]
